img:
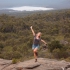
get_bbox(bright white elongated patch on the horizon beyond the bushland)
[8,6,53,11]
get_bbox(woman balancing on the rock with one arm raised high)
[30,26,47,62]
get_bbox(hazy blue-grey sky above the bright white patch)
[0,0,70,8]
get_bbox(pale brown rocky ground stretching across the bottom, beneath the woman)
[0,58,70,70]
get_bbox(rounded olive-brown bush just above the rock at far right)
[52,47,70,59]
